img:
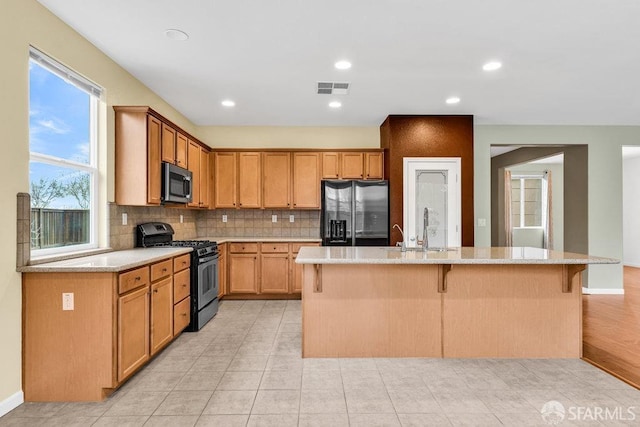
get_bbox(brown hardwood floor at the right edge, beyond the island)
[582,267,640,388]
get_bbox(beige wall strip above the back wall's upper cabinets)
[199,126,380,148]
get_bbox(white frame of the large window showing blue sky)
[29,46,104,258]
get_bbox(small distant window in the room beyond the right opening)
[511,175,546,228]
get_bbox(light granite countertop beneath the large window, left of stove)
[18,247,192,273]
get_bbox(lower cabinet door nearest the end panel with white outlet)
[118,287,149,382]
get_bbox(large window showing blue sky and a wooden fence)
[29,48,102,256]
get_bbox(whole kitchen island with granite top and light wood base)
[296,247,619,358]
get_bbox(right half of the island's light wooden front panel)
[442,265,582,358]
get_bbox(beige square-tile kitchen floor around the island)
[0,301,640,427]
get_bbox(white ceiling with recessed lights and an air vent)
[39,0,640,126]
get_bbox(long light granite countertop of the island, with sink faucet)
[296,246,620,264]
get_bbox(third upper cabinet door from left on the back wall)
[262,153,291,208]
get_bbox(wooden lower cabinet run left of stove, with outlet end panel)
[22,254,190,402]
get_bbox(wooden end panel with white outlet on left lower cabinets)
[22,273,116,401]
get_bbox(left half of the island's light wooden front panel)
[302,264,442,357]
